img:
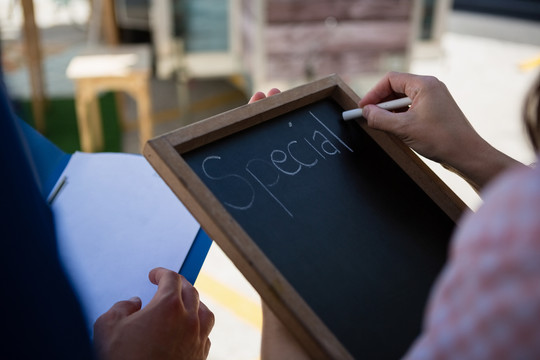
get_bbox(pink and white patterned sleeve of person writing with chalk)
[406,164,540,359]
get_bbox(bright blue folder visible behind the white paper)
[19,120,212,284]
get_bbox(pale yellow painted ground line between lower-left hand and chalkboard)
[195,271,262,331]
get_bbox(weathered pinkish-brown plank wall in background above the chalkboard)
[244,0,414,84]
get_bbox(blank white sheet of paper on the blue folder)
[51,152,199,329]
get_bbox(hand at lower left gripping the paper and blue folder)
[94,268,214,360]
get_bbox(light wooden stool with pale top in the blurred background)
[66,45,153,152]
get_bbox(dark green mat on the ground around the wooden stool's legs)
[13,92,122,154]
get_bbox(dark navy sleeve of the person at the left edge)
[0,78,92,359]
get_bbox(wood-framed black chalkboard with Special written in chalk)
[143,75,466,359]
